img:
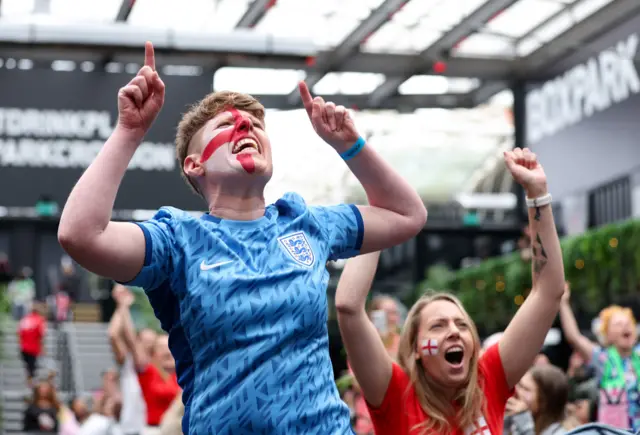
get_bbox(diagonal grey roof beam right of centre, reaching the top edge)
[369,0,517,107]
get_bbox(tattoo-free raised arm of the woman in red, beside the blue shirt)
[336,252,393,407]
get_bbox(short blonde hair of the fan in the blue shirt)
[176,91,264,194]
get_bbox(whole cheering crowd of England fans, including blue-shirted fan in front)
[2,43,640,435]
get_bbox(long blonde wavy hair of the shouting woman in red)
[398,292,484,434]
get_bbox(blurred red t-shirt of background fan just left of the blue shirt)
[138,364,180,426]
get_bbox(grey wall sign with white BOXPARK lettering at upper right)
[526,14,640,197]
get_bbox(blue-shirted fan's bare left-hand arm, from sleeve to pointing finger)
[58,42,164,281]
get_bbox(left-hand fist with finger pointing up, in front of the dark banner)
[118,42,164,137]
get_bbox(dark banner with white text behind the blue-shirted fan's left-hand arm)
[0,68,212,210]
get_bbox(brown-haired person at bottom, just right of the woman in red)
[505,364,569,435]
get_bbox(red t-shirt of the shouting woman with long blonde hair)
[369,344,512,435]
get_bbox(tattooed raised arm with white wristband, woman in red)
[499,148,564,387]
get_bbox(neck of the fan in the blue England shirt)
[206,186,265,221]
